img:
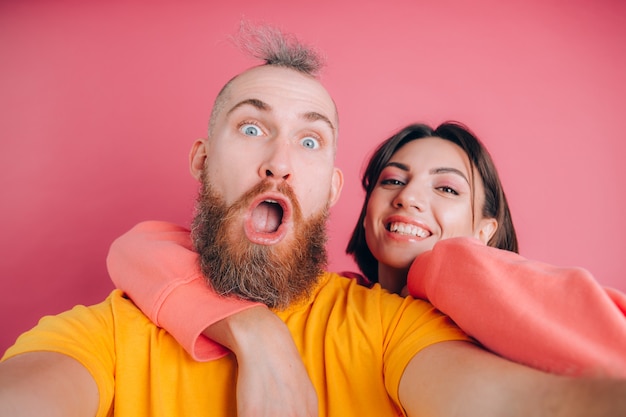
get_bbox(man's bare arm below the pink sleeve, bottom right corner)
[399,342,626,417]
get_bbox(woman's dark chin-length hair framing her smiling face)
[346,122,518,282]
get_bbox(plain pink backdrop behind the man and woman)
[0,0,626,351]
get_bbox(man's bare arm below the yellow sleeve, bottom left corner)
[0,352,99,417]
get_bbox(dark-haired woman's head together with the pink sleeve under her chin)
[347,123,626,377]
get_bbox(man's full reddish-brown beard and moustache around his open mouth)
[192,178,328,309]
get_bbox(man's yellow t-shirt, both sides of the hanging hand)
[3,273,467,417]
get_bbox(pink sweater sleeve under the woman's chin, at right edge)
[408,238,626,378]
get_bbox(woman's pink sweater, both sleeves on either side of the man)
[107,221,626,377]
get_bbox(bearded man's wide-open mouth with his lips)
[245,193,291,245]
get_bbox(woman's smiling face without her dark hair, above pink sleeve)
[363,137,496,278]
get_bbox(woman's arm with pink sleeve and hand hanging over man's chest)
[107,221,318,417]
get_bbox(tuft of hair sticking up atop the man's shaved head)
[231,20,326,77]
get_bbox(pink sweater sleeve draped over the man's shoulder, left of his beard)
[107,221,262,361]
